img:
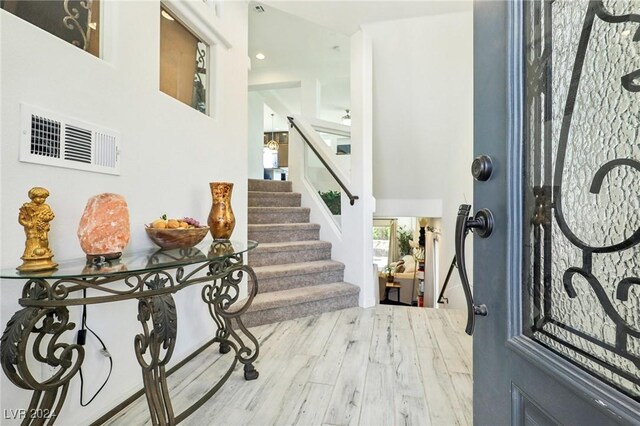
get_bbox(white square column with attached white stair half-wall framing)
[289,32,378,307]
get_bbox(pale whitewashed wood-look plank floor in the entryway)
[108,305,472,426]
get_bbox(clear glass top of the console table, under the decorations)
[0,240,258,280]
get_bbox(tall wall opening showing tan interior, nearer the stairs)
[160,7,209,114]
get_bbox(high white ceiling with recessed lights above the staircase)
[249,0,468,129]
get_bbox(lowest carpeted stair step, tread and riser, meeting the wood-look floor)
[242,282,360,327]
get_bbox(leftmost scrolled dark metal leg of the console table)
[0,307,84,425]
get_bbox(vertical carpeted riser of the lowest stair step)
[242,293,358,327]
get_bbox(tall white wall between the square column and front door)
[362,8,473,307]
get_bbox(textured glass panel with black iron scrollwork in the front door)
[525,0,640,400]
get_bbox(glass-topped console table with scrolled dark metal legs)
[0,241,259,425]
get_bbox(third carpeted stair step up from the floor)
[249,241,331,267]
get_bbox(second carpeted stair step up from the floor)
[253,260,344,294]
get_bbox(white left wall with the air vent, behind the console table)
[0,1,248,424]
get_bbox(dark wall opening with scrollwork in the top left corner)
[0,0,100,57]
